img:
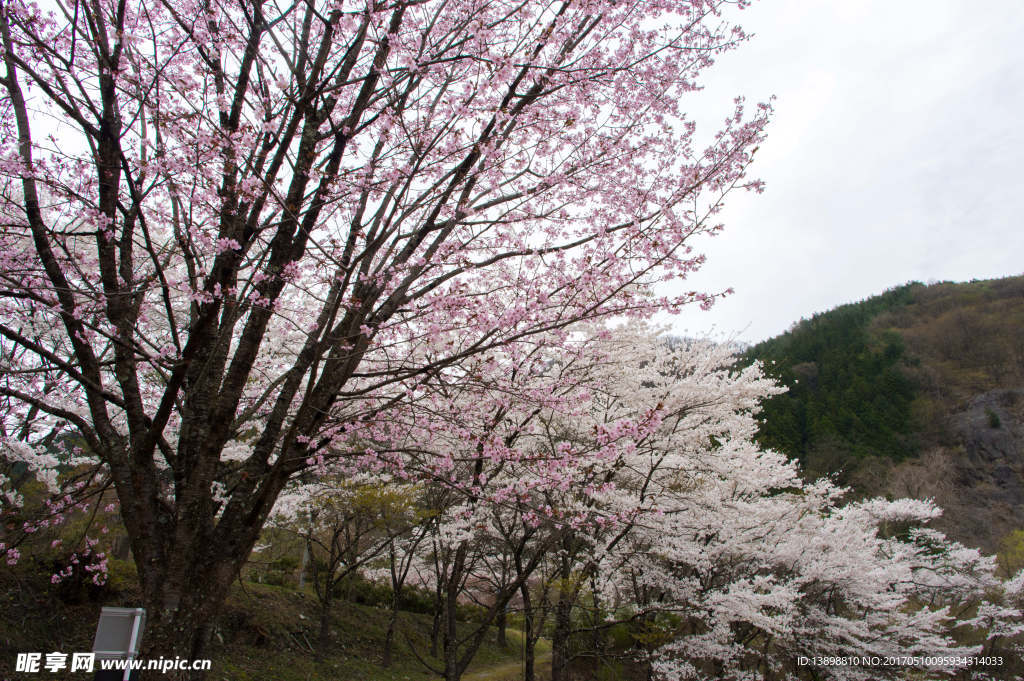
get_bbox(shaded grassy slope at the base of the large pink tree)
[0,563,550,681]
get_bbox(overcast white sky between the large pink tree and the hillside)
[670,0,1024,342]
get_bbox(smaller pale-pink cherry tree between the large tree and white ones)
[385,333,595,681]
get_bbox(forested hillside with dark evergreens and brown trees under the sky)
[745,276,1024,550]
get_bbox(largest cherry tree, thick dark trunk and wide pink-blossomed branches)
[0,0,768,656]
